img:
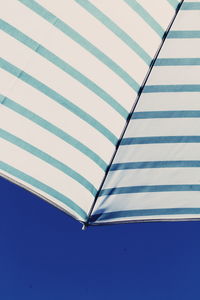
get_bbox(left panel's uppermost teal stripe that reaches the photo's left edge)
[0,21,128,119]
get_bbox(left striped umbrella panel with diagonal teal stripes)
[0,0,186,222]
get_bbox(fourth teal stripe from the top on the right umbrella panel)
[143,84,200,93]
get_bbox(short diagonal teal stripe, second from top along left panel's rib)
[124,0,164,37]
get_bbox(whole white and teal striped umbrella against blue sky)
[1,0,200,226]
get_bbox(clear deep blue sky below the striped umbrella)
[0,179,200,300]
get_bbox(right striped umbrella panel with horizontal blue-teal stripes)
[91,1,200,223]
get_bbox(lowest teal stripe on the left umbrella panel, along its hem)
[0,162,87,220]
